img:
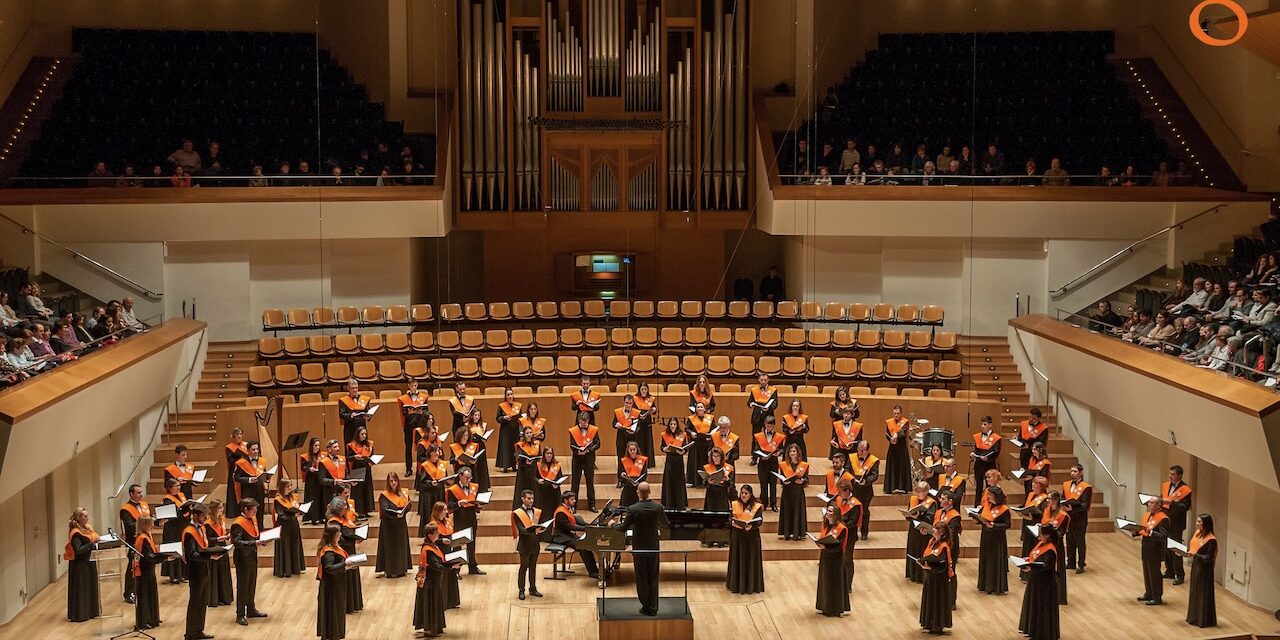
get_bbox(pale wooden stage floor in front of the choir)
[0,534,1280,640]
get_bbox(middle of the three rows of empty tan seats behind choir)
[257,326,956,360]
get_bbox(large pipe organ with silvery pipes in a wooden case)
[452,0,751,211]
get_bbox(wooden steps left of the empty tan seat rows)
[146,342,257,491]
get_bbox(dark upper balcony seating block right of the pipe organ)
[782,32,1178,184]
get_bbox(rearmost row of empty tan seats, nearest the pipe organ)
[262,300,945,333]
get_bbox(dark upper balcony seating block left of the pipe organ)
[22,29,434,187]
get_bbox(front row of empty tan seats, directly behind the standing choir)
[250,355,961,389]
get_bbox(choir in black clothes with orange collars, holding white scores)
[64,384,1217,640]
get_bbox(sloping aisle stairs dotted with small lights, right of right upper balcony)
[1114,58,1244,191]
